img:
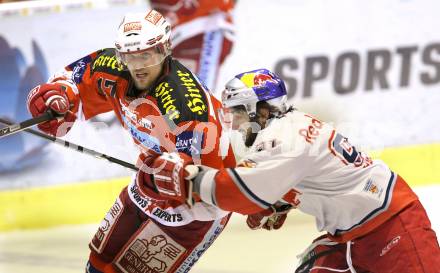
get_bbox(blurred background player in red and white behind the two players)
[150,0,236,90]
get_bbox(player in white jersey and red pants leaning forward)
[147,69,440,273]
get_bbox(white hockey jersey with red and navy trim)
[195,111,417,241]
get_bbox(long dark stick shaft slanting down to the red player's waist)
[0,118,139,171]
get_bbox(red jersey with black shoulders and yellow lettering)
[51,49,235,225]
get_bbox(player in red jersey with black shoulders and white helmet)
[27,10,235,273]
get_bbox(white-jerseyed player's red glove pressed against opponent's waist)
[153,153,199,203]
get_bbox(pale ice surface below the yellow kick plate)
[0,186,440,273]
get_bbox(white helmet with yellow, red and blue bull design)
[222,69,287,118]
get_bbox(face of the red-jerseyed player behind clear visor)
[122,49,165,90]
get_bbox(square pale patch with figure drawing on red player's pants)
[115,221,186,273]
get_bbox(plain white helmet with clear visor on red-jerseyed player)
[115,10,171,67]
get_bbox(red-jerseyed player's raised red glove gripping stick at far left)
[27,83,76,136]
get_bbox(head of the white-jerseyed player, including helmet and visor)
[219,69,287,149]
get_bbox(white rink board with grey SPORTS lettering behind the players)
[0,0,440,186]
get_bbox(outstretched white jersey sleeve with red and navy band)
[194,149,305,214]
